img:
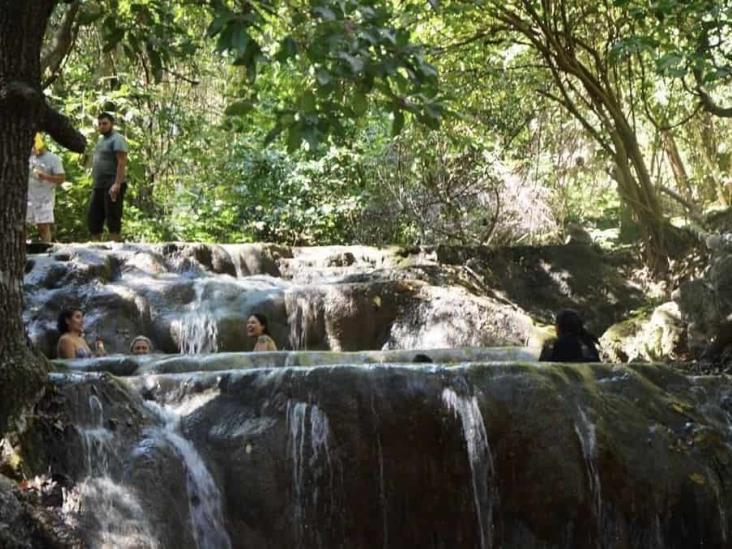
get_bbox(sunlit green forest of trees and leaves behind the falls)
[38,0,732,262]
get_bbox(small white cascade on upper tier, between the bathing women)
[170,279,219,355]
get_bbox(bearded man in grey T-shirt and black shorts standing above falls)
[89,112,128,242]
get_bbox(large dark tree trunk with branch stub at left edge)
[0,0,83,434]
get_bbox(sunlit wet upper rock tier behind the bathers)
[24,243,638,357]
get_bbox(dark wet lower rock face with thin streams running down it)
[17,357,732,548]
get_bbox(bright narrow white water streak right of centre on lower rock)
[442,388,499,549]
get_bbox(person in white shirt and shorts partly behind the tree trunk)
[26,133,66,242]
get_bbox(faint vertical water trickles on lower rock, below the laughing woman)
[287,401,333,546]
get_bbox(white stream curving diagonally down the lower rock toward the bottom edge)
[146,402,231,549]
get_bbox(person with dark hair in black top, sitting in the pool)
[539,309,600,362]
